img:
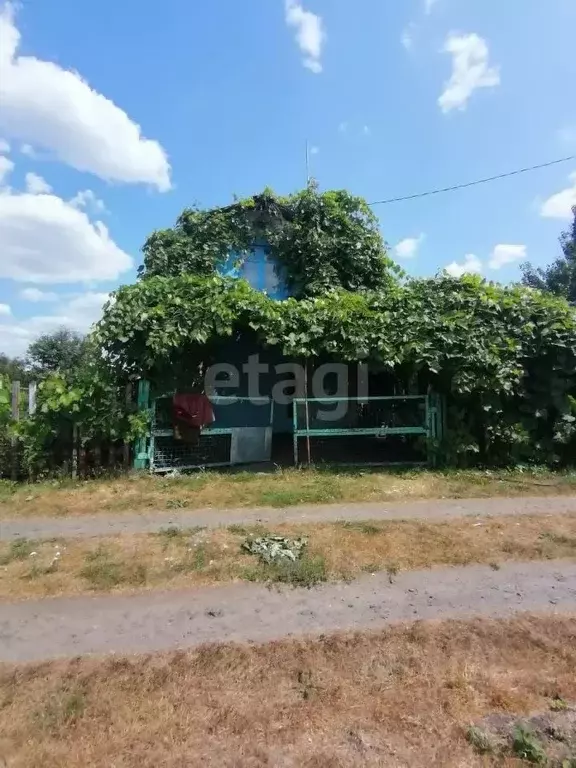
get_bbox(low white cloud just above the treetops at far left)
[0,292,109,357]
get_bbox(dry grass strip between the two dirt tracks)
[0,514,576,600]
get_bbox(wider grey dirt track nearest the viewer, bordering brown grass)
[0,561,576,662]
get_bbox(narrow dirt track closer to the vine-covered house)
[0,496,576,541]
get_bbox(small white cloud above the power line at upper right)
[438,34,500,112]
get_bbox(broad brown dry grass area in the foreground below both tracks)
[0,616,576,768]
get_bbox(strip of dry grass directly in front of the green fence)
[0,469,576,518]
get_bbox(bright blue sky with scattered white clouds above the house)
[0,0,576,354]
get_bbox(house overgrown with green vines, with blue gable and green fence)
[96,186,576,471]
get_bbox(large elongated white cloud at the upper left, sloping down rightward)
[0,3,170,191]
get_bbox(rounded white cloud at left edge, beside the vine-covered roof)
[0,190,132,283]
